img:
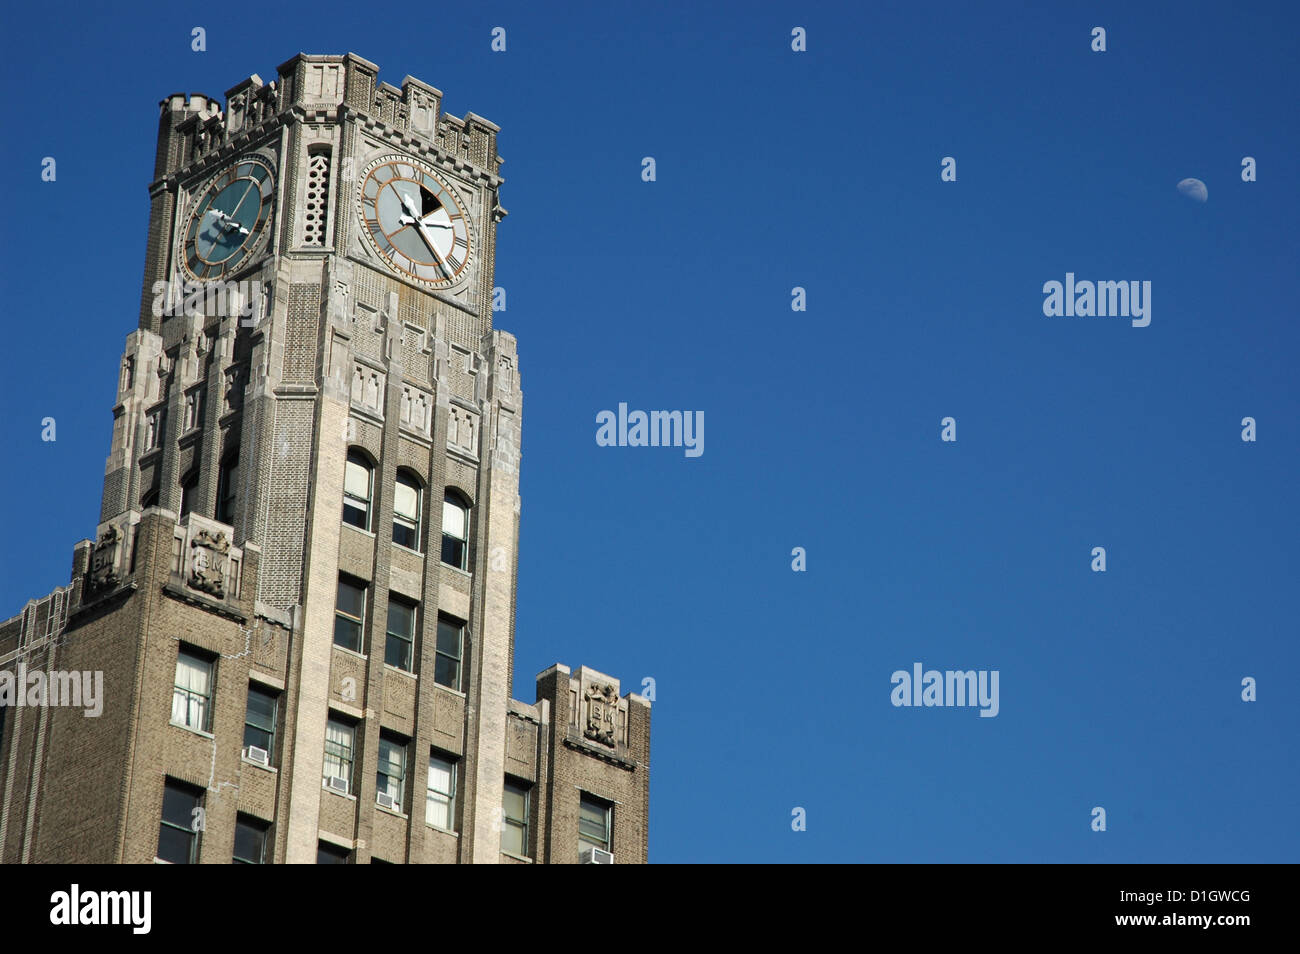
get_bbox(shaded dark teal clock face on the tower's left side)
[181,159,276,281]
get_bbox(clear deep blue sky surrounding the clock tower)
[0,1,1300,862]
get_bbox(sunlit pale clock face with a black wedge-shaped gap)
[356,156,473,289]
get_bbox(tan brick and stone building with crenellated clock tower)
[0,55,650,863]
